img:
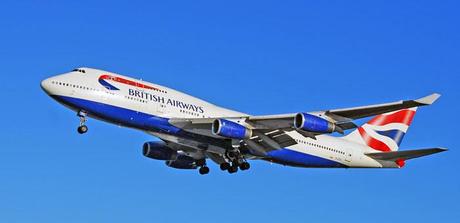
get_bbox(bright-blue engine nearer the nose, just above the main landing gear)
[212,119,252,139]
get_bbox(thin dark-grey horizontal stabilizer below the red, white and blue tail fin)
[366,148,447,161]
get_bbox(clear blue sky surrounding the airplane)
[0,0,460,223]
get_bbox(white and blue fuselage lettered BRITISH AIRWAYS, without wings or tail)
[42,68,383,168]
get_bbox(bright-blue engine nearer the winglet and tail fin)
[294,113,336,133]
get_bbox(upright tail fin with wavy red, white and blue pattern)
[344,107,417,152]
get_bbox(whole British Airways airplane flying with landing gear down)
[41,67,447,175]
